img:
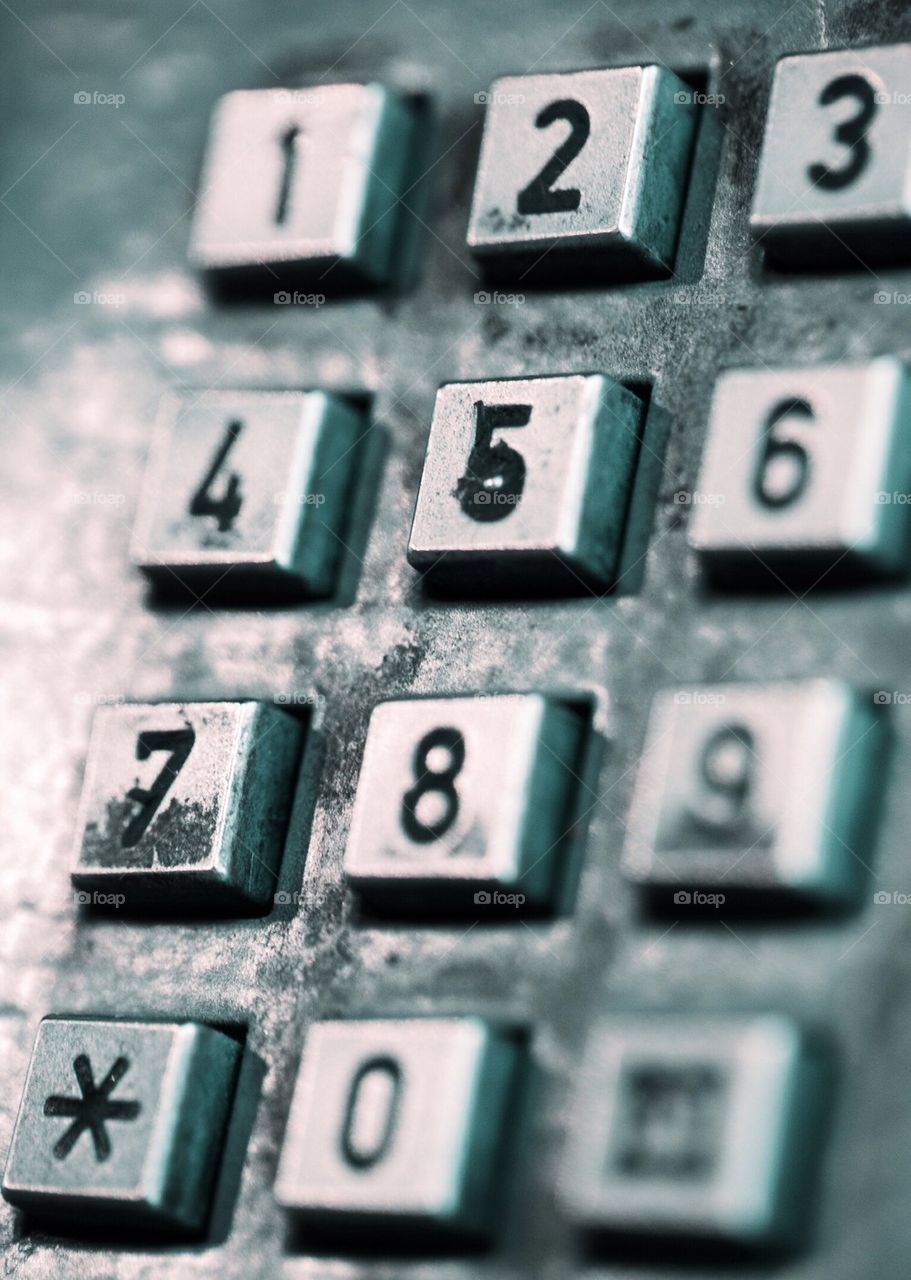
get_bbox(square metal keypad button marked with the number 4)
[132,392,365,599]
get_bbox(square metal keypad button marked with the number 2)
[468,67,697,279]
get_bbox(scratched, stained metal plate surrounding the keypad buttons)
[0,0,911,1280]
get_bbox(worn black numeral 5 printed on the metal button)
[454,401,531,524]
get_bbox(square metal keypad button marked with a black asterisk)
[3,1018,241,1236]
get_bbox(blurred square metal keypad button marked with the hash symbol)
[563,1015,828,1247]
